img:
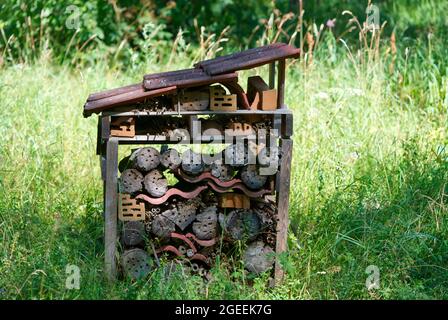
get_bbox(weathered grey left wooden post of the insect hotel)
[104,137,118,282]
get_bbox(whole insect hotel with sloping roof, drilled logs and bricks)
[84,43,299,283]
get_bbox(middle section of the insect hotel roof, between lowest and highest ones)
[143,70,238,90]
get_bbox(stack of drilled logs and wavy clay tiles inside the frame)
[119,144,279,279]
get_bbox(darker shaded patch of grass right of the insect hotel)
[289,141,448,299]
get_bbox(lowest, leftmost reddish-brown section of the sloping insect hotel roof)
[83,86,177,117]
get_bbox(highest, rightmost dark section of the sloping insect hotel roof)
[200,45,300,75]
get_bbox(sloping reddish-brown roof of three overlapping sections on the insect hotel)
[83,43,300,117]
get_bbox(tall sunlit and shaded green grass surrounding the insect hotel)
[0,30,448,299]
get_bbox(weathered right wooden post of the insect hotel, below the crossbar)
[275,139,292,284]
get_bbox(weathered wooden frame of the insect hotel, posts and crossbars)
[97,59,293,284]
